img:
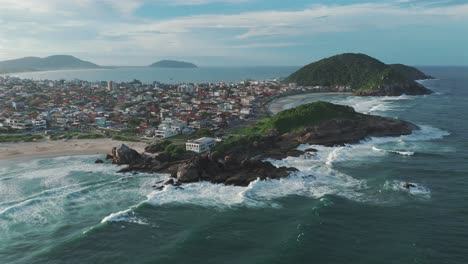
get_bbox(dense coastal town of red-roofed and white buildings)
[0,76,349,153]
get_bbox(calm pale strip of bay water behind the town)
[14,66,300,83]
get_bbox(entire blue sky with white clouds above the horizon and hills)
[0,0,468,66]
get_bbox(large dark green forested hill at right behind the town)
[286,53,432,96]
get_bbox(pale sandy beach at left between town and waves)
[0,138,146,160]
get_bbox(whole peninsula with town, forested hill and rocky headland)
[0,53,432,188]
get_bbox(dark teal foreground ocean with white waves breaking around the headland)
[0,67,468,264]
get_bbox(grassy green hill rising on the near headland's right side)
[215,101,418,159]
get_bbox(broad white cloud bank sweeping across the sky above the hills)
[0,0,468,64]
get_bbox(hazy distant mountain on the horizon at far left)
[0,55,100,73]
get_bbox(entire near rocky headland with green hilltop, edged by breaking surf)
[107,102,418,188]
